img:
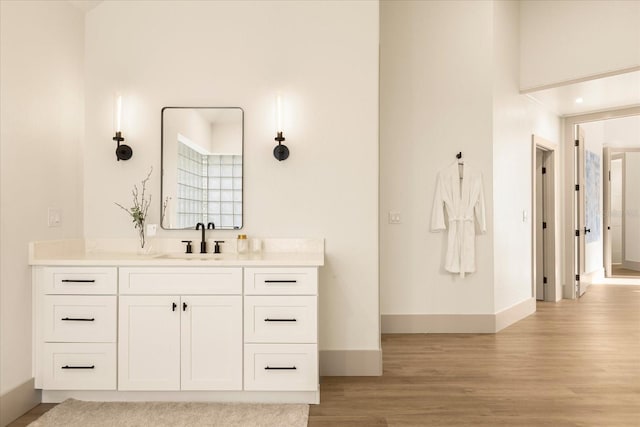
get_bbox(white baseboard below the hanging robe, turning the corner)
[382,298,536,334]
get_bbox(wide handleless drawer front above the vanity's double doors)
[119,267,242,295]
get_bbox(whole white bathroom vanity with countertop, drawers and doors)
[30,239,324,403]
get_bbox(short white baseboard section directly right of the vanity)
[320,349,382,377]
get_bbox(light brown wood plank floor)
[10,285,640,427]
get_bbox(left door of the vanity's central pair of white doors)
[118,296,181,390]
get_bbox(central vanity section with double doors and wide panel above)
[118,267,242,390]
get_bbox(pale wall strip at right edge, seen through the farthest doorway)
[623,152,640,270]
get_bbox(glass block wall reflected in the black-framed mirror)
[176,143,242,229]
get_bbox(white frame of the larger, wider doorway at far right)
[561,106,640,299]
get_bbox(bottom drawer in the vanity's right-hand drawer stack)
[244,344,318,391]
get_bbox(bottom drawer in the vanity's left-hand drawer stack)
[42,343,116,390]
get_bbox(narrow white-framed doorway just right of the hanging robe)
[531,135,560,301]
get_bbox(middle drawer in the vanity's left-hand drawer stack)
[43,295,116,342]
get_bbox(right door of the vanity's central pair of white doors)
[180,295,242,390]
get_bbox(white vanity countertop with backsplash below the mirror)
[29,239,324,267]
